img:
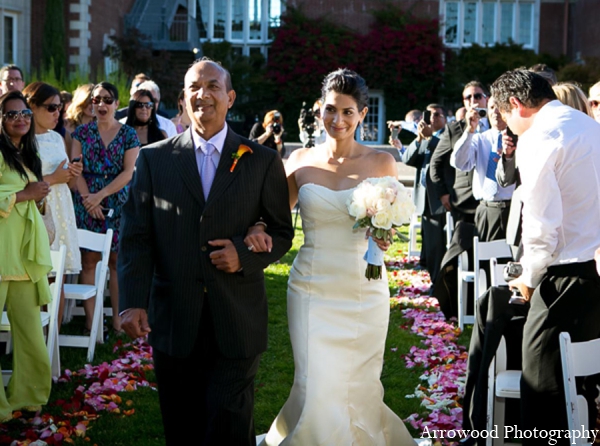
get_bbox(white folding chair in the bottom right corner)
[559,332,600,446]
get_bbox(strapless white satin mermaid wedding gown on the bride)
[261,184,415,446]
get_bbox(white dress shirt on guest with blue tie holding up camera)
[450,129,515,201]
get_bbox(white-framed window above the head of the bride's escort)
[197,0,282,56]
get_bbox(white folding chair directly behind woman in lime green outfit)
[0,245,67,386]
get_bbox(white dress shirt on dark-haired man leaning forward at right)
[517,100,600,288]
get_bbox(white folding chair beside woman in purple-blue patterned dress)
[59,229,113,362]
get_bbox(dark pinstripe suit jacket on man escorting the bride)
[118,125,294,358]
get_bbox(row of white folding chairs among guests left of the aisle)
[0,229,113,386]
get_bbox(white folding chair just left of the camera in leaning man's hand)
[458,237,512,330]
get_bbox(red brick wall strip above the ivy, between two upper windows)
[287,0,439,33]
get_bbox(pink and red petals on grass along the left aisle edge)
[0,340,154,446]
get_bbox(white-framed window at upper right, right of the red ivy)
[440,0,540,50]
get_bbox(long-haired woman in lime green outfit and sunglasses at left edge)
[0,91,52,422]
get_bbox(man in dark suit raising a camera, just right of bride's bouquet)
[392,104,446,283]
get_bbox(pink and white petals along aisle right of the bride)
[388,257,467,440]
